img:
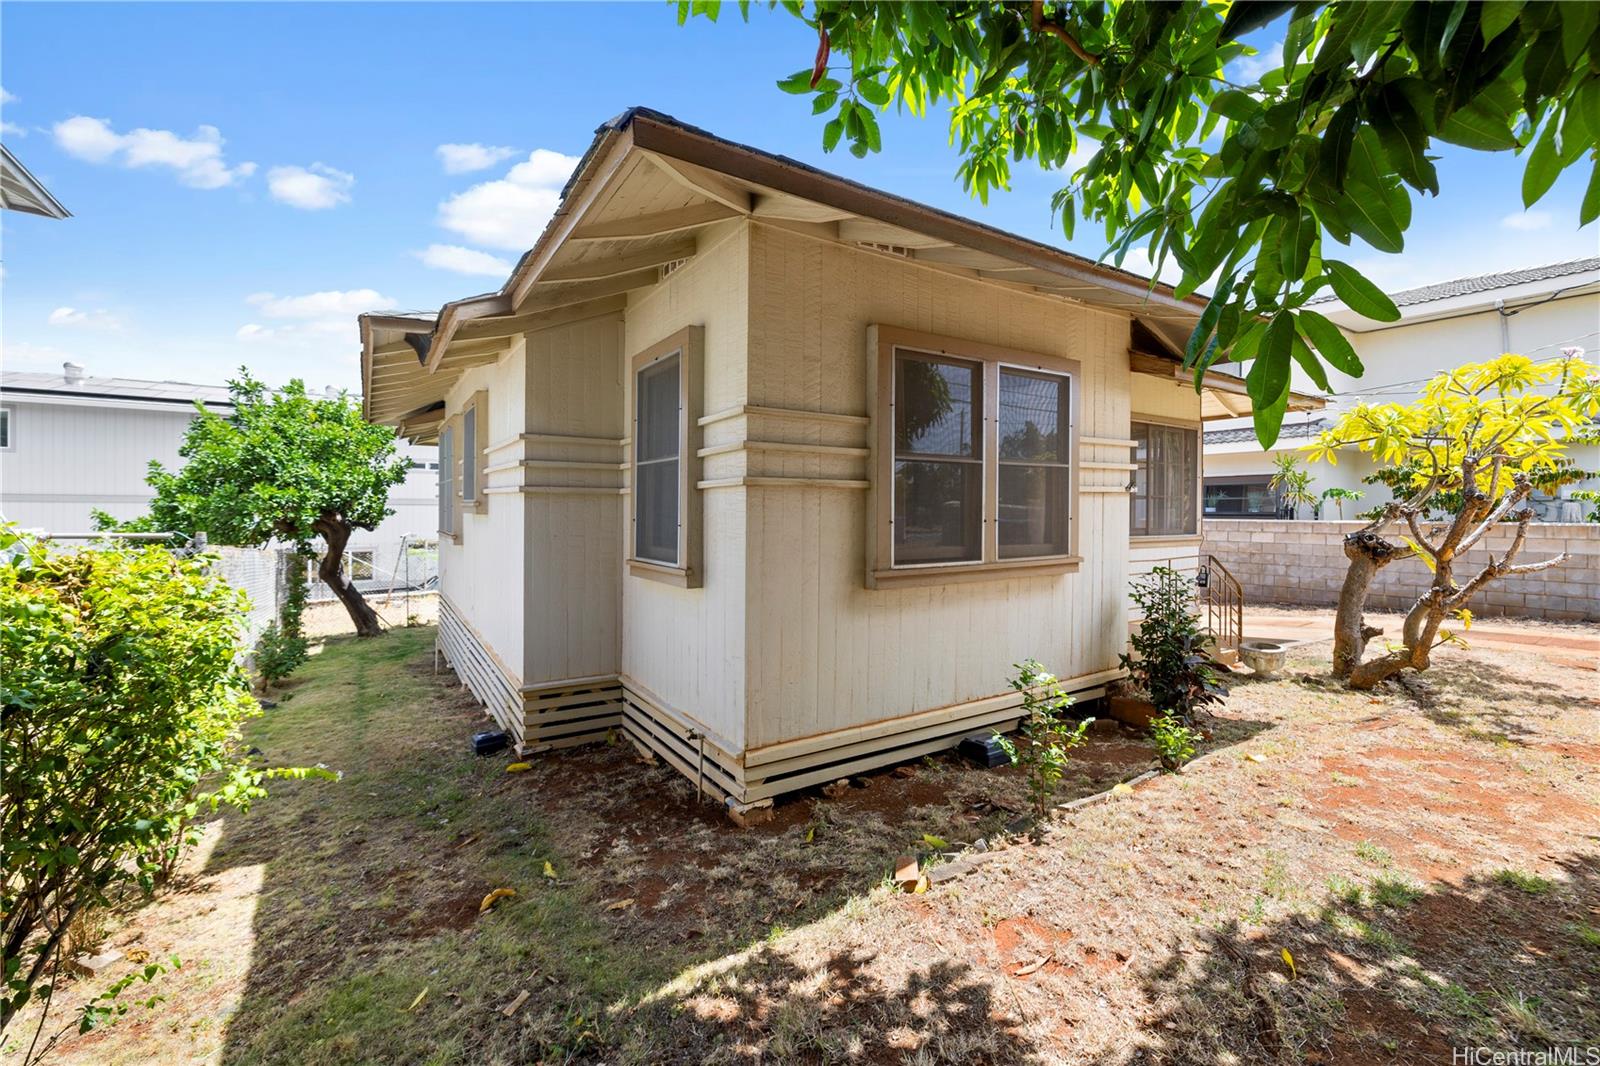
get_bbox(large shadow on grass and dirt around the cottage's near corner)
[181,629,1269,1064]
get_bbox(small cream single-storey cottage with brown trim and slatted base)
[360,109,1314,805]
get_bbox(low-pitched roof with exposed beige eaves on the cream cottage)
[360,107,1205,435]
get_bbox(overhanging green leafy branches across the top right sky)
[678,0,1600,447]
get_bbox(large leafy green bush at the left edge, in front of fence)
[0,527,331,1031]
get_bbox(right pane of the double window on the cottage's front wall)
[997,368,1070,559]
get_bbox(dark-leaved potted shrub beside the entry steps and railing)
[1120,567,1227,725]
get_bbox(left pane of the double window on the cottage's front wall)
[893,352,984,565]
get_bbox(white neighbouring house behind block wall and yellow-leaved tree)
[1205,258,1600,522]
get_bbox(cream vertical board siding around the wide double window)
[739,226,1177,749]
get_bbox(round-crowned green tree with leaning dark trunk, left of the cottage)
[146,370,406,637]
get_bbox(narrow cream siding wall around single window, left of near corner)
[614,222,749,751]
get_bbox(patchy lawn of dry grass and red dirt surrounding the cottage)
[13,629,1600,1063]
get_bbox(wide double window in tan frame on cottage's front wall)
[867,327,1077,586]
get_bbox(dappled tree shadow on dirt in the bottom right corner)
[1117,855,1600,1066]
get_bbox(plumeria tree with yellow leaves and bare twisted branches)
[1312,349,1600,688]
